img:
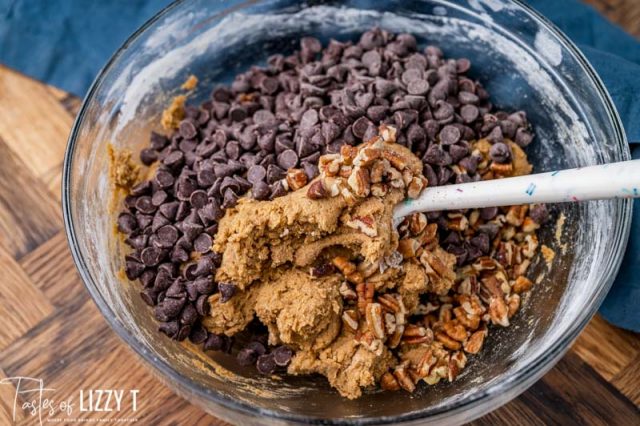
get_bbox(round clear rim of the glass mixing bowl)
[61,0,633,425]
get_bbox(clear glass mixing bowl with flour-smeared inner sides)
[63,0,631,424]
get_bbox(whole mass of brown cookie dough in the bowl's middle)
[204,140,455,398]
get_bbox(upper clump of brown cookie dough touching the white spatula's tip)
[213,144,422,289]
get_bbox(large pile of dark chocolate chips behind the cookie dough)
[118,28,533,373]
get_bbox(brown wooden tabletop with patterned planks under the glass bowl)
[0,0,640,425]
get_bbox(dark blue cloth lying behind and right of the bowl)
[0,0,640,331]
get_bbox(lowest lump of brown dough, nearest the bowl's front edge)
[287,333,396,399]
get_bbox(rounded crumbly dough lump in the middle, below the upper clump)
[256,268,342,350]
